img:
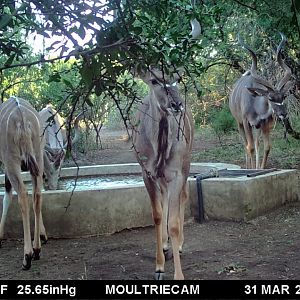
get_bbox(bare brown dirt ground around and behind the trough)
[0,127,300,279]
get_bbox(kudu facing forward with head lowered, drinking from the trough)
[39,104,84,190]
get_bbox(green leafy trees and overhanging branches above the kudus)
[0,0,300,166]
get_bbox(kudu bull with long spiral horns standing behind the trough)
[229,33,291,169]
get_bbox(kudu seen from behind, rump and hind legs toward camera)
[0,97,46,270]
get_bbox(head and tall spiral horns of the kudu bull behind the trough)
[238,33,292,120]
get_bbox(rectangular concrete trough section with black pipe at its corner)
[190,169,300,221]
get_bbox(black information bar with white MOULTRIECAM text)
[0,280,300,299]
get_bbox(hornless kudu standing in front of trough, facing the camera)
[133,69,194,279]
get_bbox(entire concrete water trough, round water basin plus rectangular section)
[0,163,299,238]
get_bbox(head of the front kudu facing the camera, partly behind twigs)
[139,69,184,114]
